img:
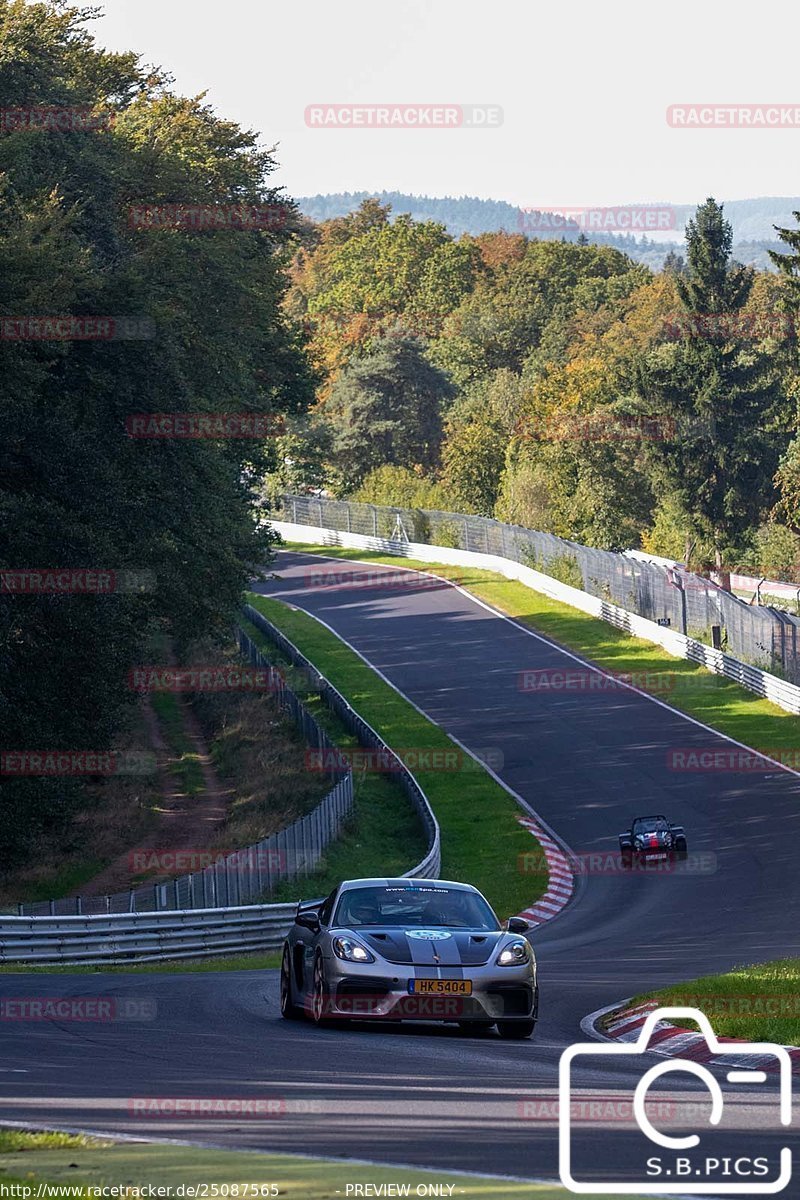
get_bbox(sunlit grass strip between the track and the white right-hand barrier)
[278,544,800,766]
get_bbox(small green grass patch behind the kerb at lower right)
[633,959,800,1046]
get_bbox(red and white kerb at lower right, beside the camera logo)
[581,1000,800,1075]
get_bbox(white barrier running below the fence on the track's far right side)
[272,511,800,714]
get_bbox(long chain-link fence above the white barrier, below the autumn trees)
[275,496,800,683]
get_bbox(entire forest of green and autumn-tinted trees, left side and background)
[0,0,800,868]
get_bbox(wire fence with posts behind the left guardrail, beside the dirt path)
[11,629,353,917]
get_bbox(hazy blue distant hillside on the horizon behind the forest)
[297,192,786,270]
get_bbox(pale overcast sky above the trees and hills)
[94,0,800,208]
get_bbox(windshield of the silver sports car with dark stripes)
[333,884,500,930]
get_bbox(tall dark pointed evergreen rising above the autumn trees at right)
[638,199,781,580]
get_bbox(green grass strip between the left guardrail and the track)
[247,593,547,918]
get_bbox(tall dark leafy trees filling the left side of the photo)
[0,0,313,868]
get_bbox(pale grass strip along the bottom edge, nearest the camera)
[0,1133,652,1200]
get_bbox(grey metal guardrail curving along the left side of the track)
[0,607,441,966]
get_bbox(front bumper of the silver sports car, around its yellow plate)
[325,958,537,1022]
